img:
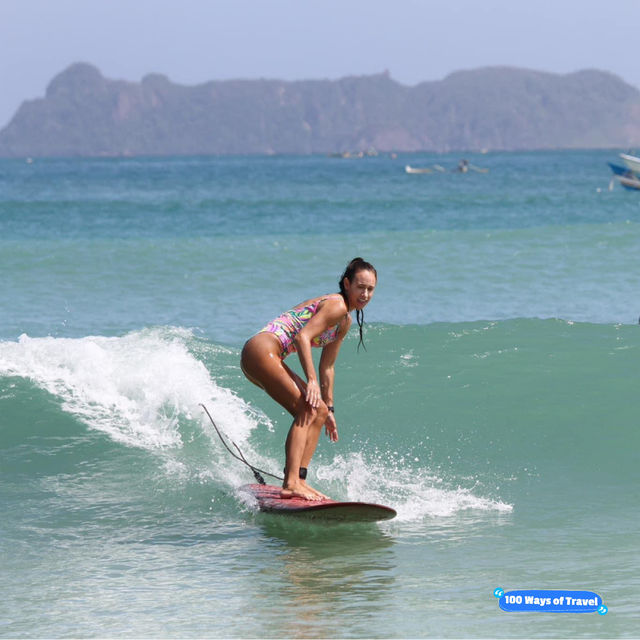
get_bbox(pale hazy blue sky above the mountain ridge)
[0,0,640,127]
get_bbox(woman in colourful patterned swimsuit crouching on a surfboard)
[240,258,378,500]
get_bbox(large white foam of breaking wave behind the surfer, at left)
[0,328,262,462]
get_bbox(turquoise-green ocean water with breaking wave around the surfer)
[0,151,640,638]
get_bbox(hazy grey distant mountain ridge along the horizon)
[0,63,640,157]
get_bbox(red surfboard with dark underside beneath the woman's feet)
[240,484,397,522]
